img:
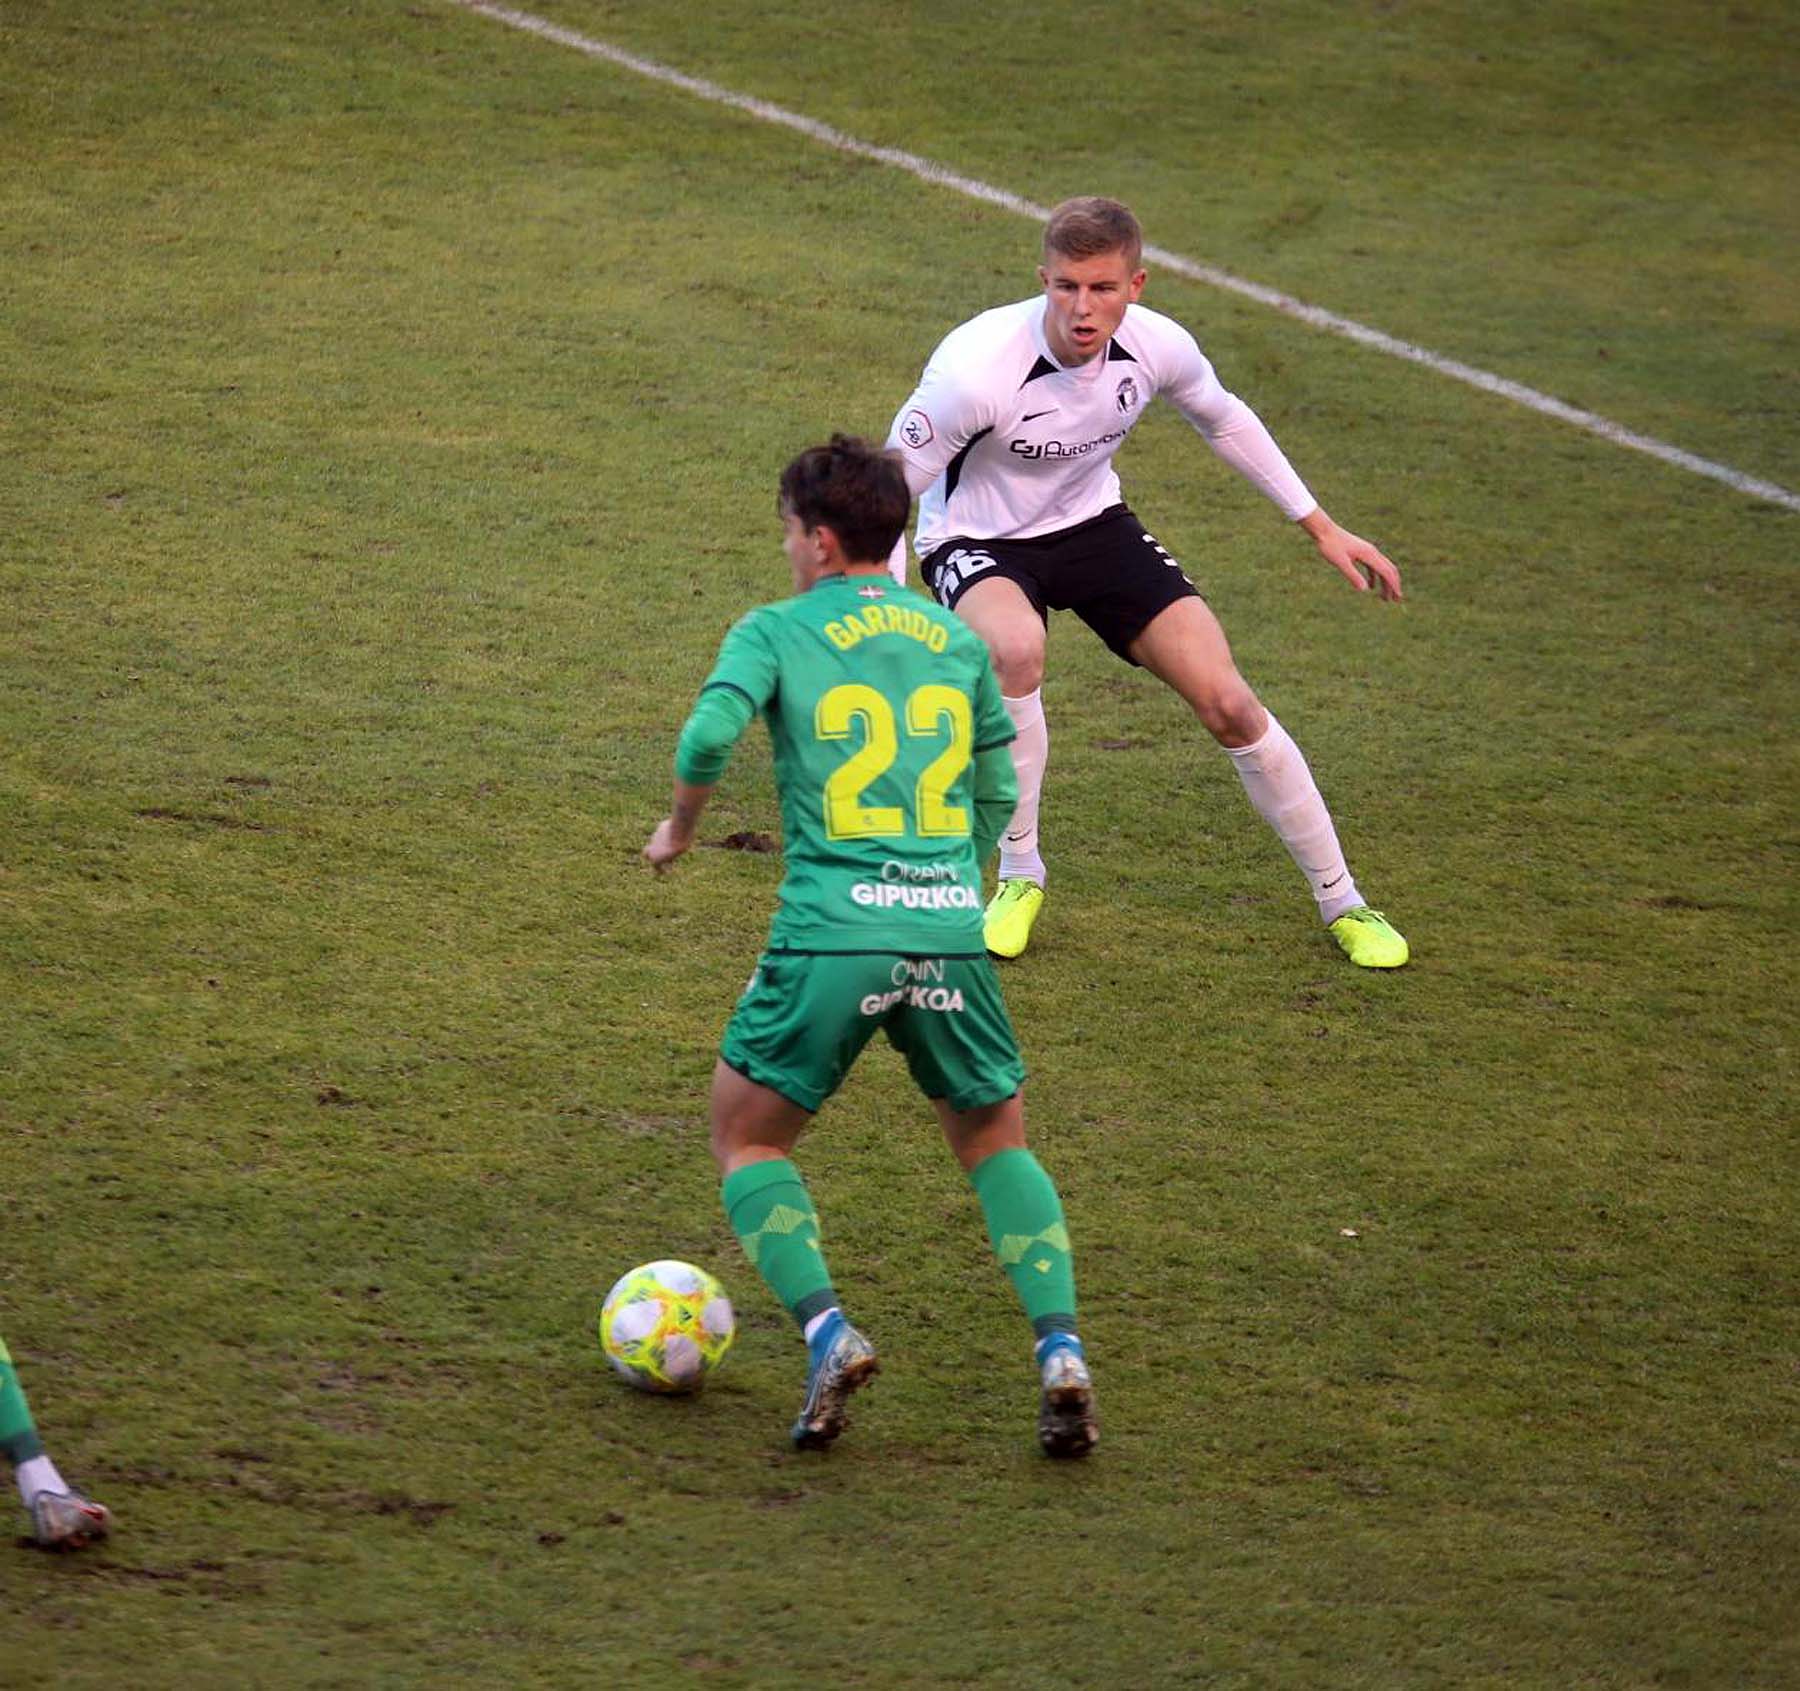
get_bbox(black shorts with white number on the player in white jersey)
[920,504,1201,663]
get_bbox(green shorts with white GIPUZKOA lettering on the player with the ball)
[718,951,1024,1109]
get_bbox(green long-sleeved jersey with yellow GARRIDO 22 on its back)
[675,573,1015,956]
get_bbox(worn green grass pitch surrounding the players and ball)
[0,0,1800,1687]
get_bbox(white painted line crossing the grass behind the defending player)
[455,0,1800,511]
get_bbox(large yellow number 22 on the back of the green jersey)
[812,681,974,839]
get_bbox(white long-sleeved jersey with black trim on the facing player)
[887,294,1316,558]
